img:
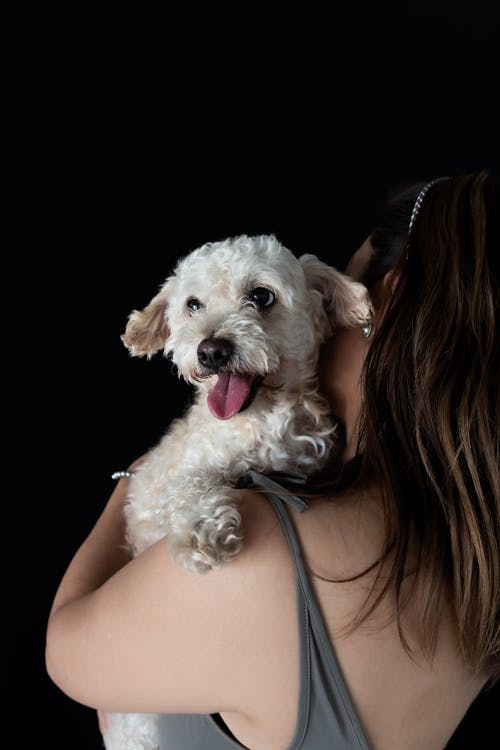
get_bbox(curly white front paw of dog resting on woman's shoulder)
[169,505,242,573]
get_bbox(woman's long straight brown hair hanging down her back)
[361,171,500,676]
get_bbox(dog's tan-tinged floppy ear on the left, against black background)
[120,285,170,359]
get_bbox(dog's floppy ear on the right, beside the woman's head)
[299,254,371,328]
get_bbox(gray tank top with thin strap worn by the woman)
[160,471,370,750]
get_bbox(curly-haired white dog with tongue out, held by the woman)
[105,235,370,750]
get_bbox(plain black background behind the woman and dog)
[11,0,500,750]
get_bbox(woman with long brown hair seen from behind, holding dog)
[47,172,500,750]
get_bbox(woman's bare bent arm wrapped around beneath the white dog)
[46,479,296,713]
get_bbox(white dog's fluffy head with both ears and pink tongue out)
[122,235,368,419]
